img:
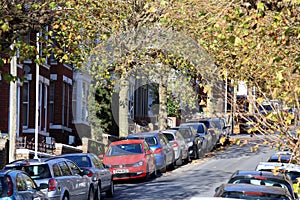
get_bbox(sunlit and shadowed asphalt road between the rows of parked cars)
[105,136,274,200]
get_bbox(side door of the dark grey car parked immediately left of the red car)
[91,154,112,189]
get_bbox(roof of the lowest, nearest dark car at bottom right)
[223,183,290,196]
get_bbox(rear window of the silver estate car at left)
[4,164,51,179]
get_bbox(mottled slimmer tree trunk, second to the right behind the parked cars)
[158,75,168,130]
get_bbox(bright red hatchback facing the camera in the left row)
[103,139,157,180]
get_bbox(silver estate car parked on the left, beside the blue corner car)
[4,157,94,200]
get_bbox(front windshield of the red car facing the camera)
[106,144,143,156]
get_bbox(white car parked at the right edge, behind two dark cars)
[255,162,300,183]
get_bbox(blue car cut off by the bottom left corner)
[0,170,46,200]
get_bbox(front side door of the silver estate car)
[66,160,90,200]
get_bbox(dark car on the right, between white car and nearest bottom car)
[228,170,298,199]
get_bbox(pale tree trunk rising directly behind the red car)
[119,79,129,137]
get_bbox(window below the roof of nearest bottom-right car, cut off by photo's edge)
[222,192,290,200]
